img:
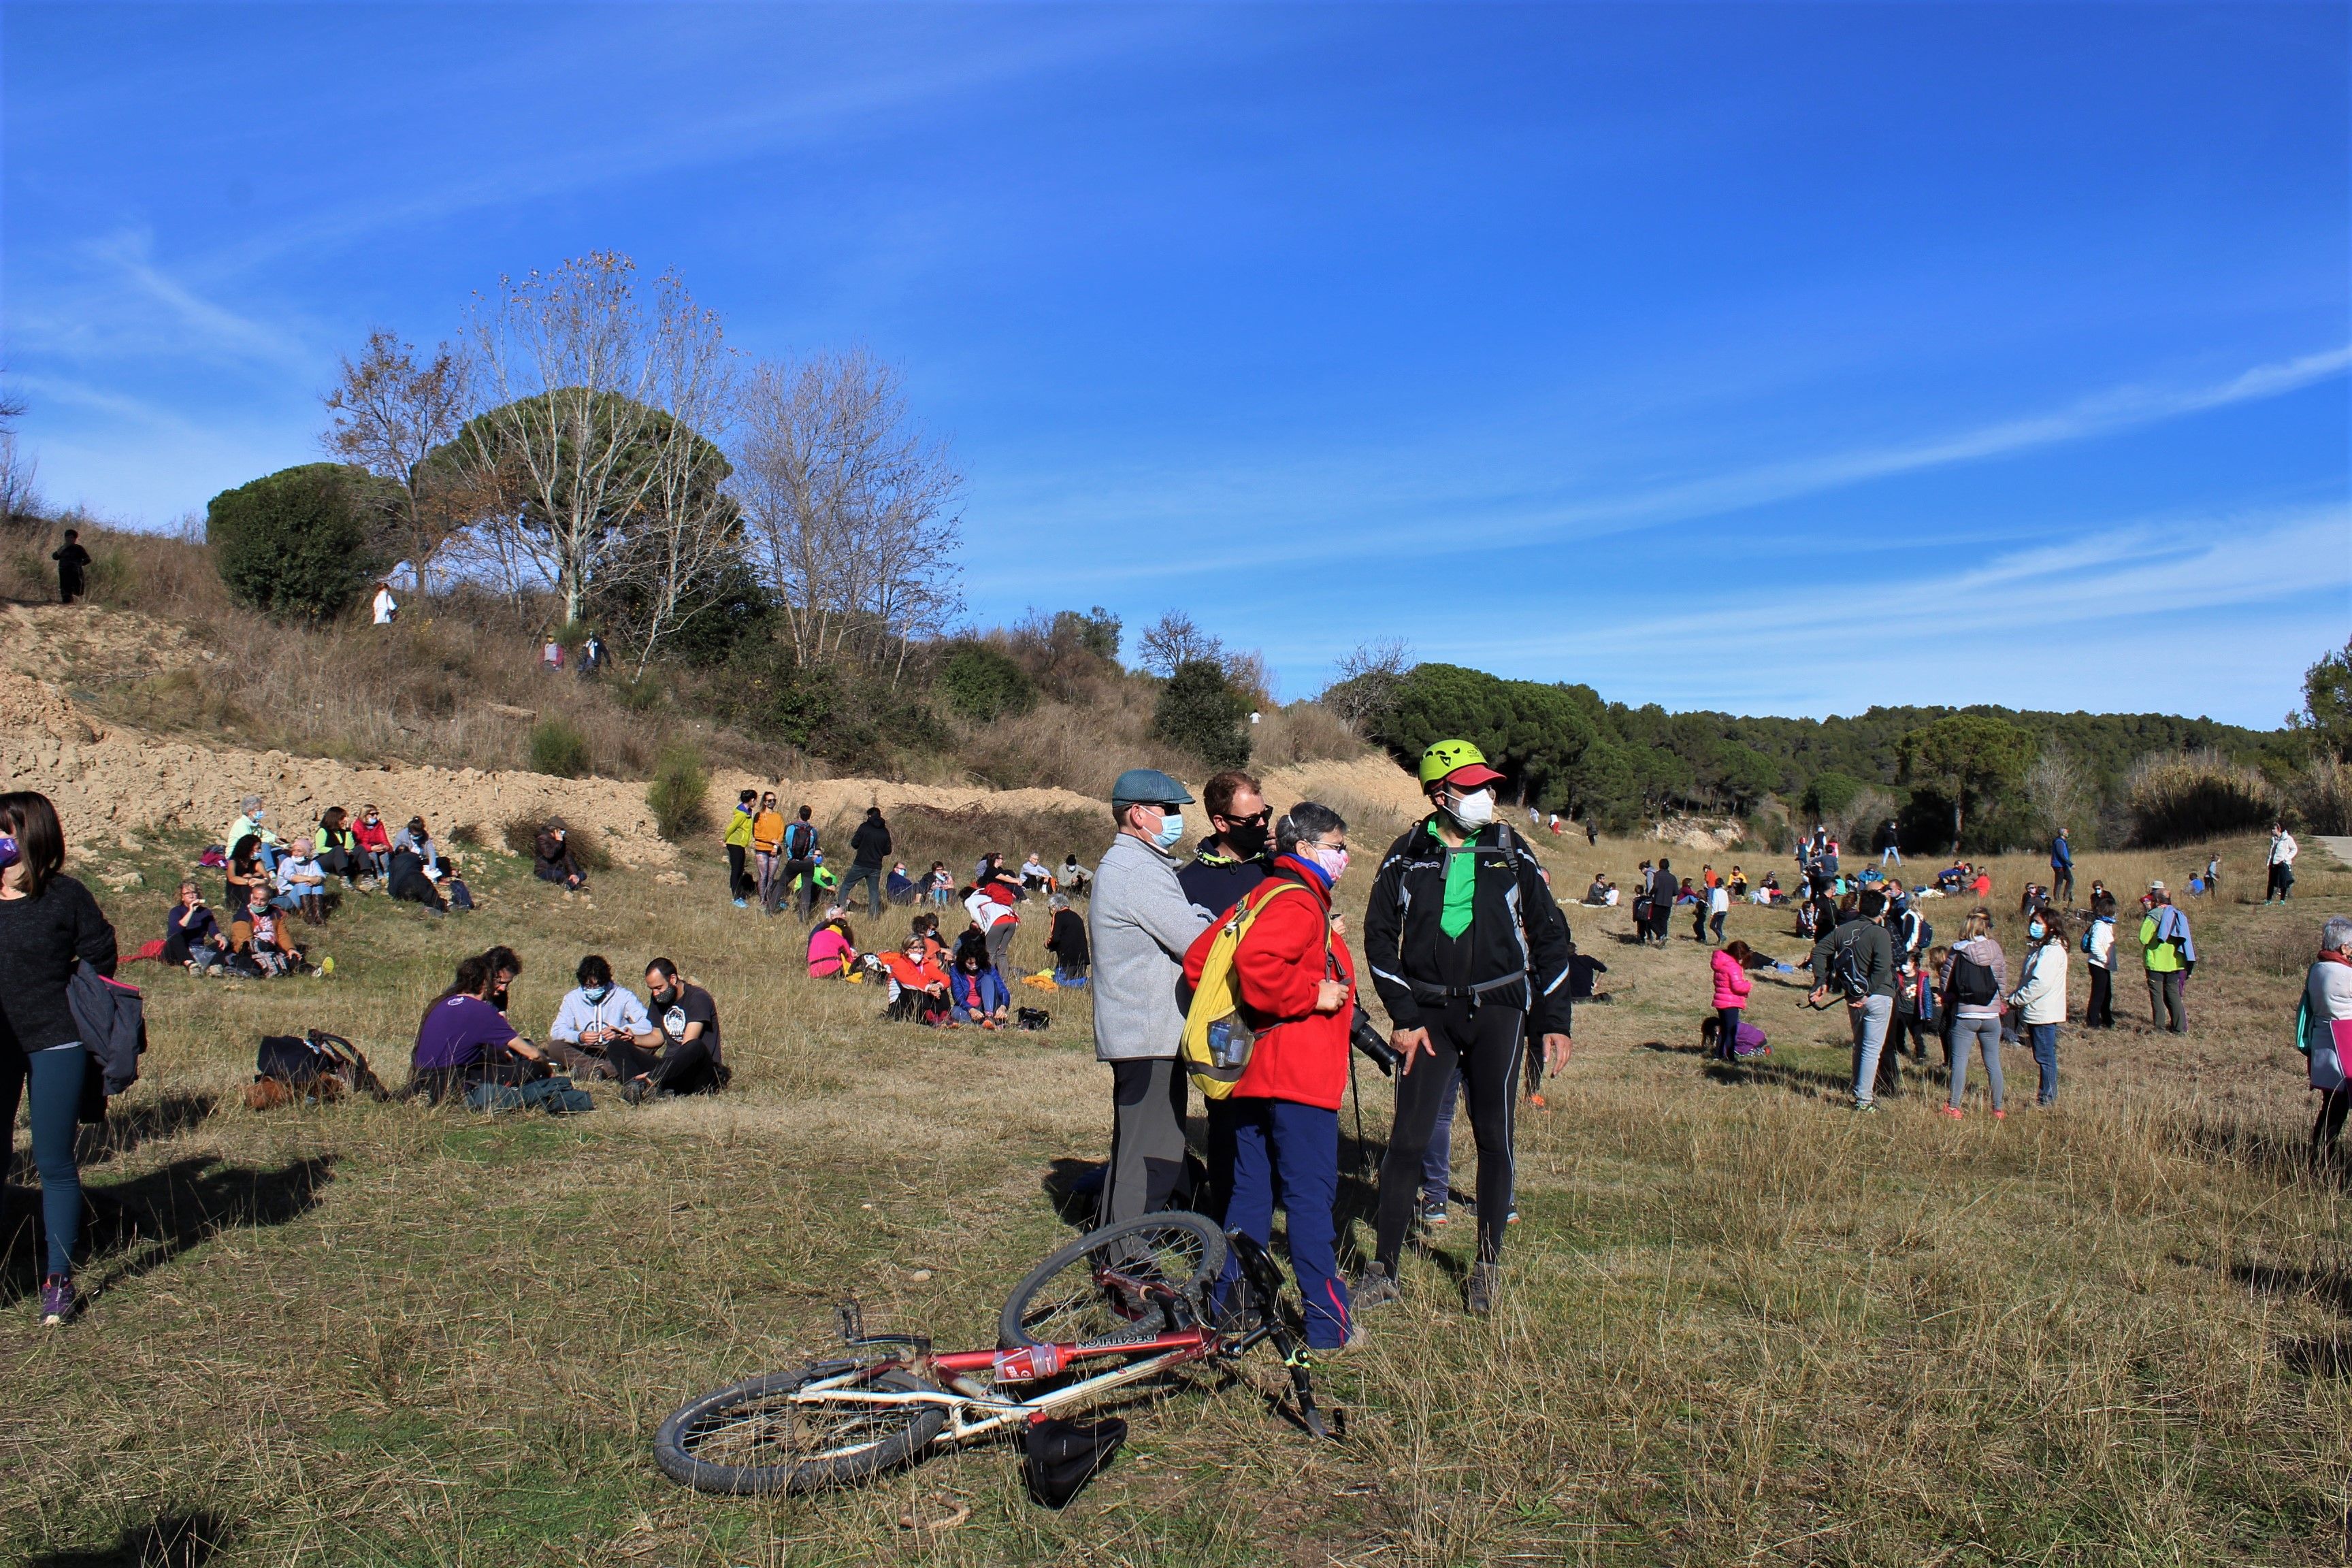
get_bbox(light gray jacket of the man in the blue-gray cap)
[1087,832,1209,1062]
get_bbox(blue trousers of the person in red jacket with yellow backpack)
[1218,1100,1348,1350]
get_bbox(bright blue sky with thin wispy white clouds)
[0,0,2352,724]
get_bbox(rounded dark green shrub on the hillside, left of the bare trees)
[205,463,388,621]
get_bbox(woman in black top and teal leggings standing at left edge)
[0,795,115,1324]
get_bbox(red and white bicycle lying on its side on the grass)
[654,1211,1331,1492]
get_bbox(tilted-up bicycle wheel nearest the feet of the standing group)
[997,1208,1226,1350]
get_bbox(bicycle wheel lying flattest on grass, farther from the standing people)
[654,1366,948,1492]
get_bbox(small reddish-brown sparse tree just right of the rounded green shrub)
[320,327,480,592]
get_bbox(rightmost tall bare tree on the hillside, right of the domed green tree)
[734,350,962,679]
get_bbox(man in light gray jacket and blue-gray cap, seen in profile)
[1087,769,1209,1225]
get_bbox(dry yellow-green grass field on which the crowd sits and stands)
[0,823,2352,1568]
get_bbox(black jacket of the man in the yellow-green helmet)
[1364,813,1576,1034]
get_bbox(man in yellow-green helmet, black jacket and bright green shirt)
[1355,740,1573,1314]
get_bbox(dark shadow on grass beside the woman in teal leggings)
[0,1154,334,1305]
